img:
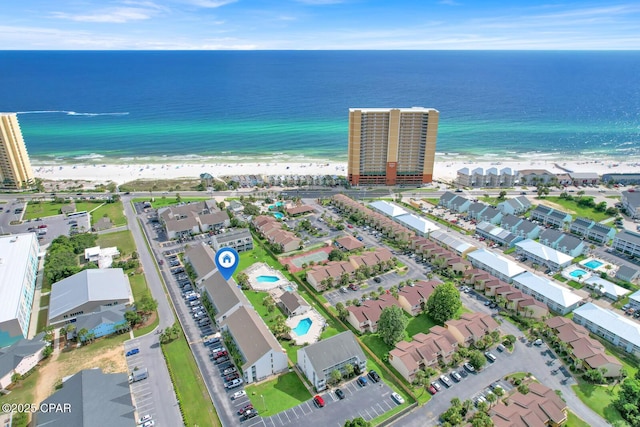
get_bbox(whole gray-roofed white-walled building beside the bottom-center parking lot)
[297,331,367,391]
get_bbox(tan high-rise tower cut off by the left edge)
[0,113,34,190]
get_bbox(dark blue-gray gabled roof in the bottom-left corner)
[36,368,136,427]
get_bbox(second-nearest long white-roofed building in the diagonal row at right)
[513,271,582,315]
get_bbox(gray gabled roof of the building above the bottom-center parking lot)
[298,331,367,380]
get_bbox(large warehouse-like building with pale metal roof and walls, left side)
[49,268,133,325]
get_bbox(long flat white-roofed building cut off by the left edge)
[0,233,40,347]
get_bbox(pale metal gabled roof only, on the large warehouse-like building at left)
[49,268,132,319]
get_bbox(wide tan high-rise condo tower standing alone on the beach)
[348,107,440,185]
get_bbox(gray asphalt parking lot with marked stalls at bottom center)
[252,379,397,427]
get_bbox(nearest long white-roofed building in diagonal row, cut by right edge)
[573,303,640,356]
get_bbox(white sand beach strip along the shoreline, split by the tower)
[34,159,640,184]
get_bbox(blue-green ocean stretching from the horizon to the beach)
[0,51,640,164]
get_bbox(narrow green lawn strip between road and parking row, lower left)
[162,335,222,426]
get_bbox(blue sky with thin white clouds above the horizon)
[0,0,640,50]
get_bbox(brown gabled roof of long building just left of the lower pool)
[221,306,284,369]
